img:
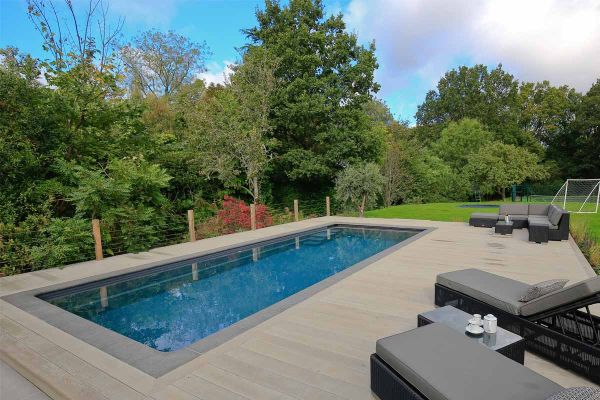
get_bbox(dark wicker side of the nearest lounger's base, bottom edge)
[371,354,427,400]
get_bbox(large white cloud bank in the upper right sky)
[345,0,600,92]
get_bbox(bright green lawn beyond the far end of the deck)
[365,201,600,241]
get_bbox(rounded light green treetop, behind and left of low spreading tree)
[433,118,492,171]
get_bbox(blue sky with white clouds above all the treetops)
[0,0,600,123]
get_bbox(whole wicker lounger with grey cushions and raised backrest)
[435,269,600,383]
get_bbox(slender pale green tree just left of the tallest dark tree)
[189,48,277,203]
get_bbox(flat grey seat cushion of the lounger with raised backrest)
[437,268,529,315]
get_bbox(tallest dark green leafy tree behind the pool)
[244,0,382,190]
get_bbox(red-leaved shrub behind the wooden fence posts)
[217,196,273,233]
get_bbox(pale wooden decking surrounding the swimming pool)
[0,217,597,400]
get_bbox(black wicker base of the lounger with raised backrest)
[435,283,600,383]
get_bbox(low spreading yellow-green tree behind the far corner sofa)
[465,142,547,199]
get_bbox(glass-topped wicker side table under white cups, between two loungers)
[417,306,525,364]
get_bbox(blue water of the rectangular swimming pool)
[45,226,418,352]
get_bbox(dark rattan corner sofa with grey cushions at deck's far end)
[469,204,569,242]
